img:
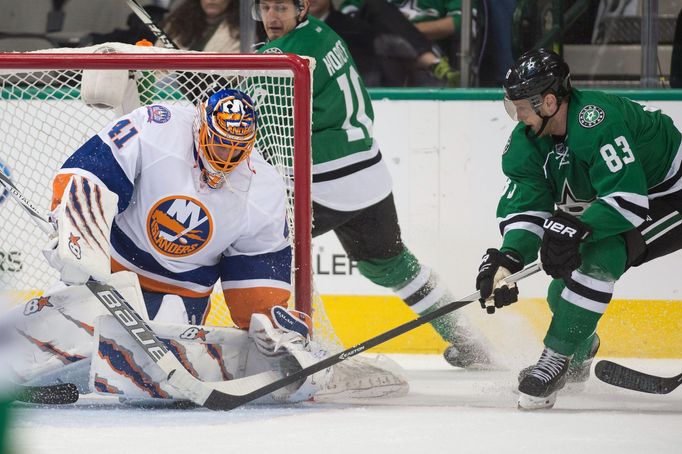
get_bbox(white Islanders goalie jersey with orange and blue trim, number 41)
[53,104,291,328]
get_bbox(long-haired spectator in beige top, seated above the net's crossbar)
[163,0,240,53]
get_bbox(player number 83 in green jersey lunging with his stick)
[476,49,682,410]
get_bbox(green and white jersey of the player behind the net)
[259,16,392,211]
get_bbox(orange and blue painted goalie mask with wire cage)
[194,89,257,189]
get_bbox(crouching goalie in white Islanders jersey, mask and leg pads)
[5,89,407,402]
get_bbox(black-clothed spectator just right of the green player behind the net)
[309,0,459,87]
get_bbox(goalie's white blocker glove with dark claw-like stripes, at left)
[43,175,118,285]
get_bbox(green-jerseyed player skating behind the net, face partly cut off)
[254,0,489,367]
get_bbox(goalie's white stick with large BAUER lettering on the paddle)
[0,172,277,410]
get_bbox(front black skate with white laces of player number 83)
[518,348,571,410]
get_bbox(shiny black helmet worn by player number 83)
[503,49,571,111]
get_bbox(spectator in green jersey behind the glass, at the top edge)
[340,0,477,68]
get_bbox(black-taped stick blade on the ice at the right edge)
[594,360,682,394]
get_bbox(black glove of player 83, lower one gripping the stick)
[476,249,523,314]
